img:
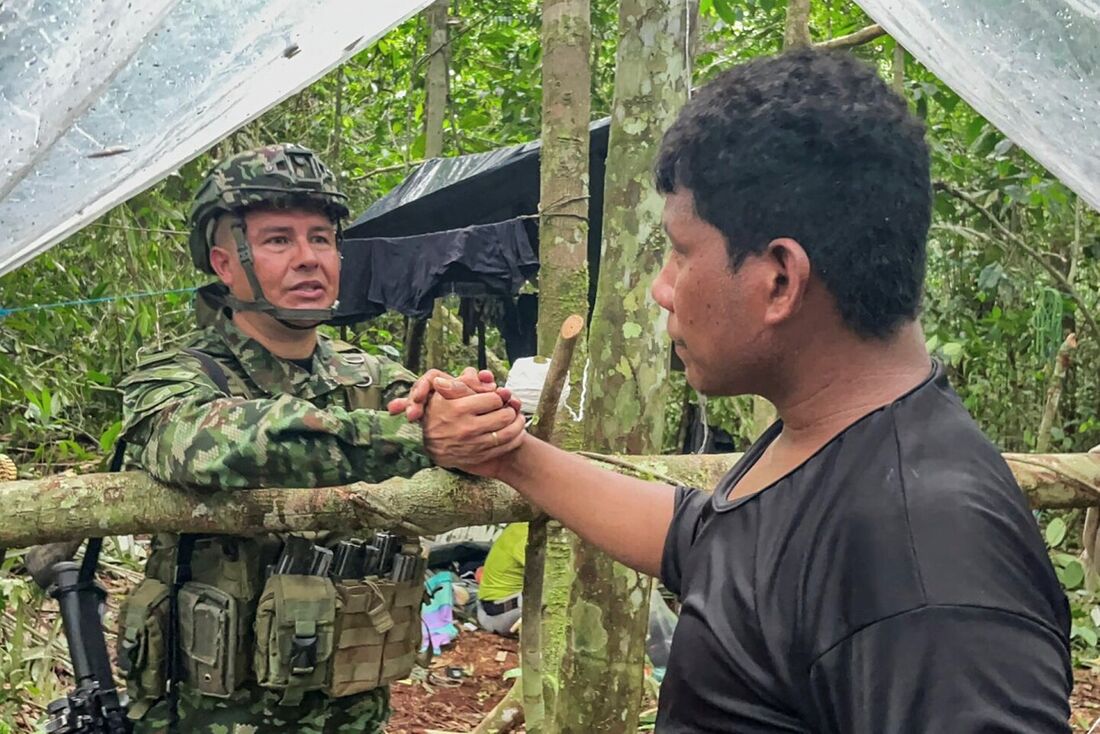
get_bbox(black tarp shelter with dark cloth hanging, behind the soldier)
[336,120,608,332]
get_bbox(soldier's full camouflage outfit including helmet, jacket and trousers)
[121,140,430,734]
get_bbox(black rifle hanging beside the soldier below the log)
[46,538,133,734]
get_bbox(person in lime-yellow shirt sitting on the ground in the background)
[477,523,527,636]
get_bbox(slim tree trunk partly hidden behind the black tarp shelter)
[424,0,450,369]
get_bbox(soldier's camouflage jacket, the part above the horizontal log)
[122,299,428,489]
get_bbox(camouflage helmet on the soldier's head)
[189,143,348,274]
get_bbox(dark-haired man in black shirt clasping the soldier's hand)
[393,51,1073,734]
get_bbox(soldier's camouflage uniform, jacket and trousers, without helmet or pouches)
[122,301,429,734]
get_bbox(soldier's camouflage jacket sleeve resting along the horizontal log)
[121,357,430,489]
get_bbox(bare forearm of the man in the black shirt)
[498,436,675,576]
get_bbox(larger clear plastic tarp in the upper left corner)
[0,0,430,275]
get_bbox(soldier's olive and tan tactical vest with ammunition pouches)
[118,342,425,719]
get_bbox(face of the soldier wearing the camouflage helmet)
[210,209,340,308]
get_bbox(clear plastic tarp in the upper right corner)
[857,0,1100,210]
